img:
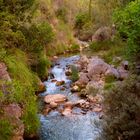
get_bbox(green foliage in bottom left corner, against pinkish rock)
[0,119,13,140]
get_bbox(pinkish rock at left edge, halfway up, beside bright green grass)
[0,62,11,81]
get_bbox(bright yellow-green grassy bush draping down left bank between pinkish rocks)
[0,49,39,134]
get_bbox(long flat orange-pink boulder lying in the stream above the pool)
[44,94,67,104]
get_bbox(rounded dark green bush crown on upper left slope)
[21,22,54,53]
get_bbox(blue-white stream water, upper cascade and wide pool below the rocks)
[39,56,101,140]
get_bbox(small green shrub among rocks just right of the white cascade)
[71,65,79,82]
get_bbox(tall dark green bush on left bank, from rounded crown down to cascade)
[21,22,54,78]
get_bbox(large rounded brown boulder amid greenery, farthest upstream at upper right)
[92,26,113,42]
